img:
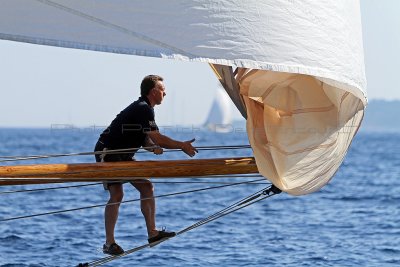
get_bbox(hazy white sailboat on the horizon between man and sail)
[204,87,232,133]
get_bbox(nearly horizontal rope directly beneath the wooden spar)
[0,174,266,195]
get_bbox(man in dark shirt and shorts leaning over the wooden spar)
[95,75,198,255]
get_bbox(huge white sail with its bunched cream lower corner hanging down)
[0,0,367,195]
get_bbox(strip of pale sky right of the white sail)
[360,0,400,99]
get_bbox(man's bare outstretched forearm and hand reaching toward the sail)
[147,131,198,157]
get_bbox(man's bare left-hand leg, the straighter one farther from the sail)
[104,184,124,245]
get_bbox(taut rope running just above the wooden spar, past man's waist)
[0,145,251,162]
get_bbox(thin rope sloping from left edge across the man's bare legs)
[0,179,264,222]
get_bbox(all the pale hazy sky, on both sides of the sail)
[0,0,400,127]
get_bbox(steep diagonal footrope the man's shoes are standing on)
[77,185,281,267]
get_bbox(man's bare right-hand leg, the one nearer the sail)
[131,180,158,237]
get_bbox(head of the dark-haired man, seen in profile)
[140,75,166,107]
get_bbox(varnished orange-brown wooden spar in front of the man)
[0,158,258,185]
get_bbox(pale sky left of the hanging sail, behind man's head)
[0,41,231,127]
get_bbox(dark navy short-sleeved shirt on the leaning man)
[99,97,158,149]
